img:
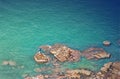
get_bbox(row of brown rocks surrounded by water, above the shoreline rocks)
[34,44,110,62]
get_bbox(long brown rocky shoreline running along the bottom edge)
[25,62,120,79]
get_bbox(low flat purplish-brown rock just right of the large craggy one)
[82,48,110,59]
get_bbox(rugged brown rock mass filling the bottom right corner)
[96,62,120,79]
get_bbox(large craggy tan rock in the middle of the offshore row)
[50,44,80,62]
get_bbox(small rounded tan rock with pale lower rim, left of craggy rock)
[34,53,49,63]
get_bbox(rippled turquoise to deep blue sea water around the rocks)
[0,0,120,79]
